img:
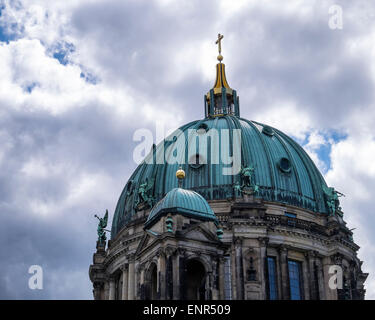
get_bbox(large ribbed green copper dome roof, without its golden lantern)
[112,115,328,238]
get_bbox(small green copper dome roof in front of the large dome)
[145,188,218,228]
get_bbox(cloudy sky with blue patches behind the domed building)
[0,0,375,299]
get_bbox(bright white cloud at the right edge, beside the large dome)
[325,129,375,299]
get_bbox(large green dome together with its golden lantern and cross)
[111,35,330,238]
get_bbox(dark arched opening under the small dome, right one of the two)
[185,259,206,300]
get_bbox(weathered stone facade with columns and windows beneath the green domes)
[89,195,368,300]
